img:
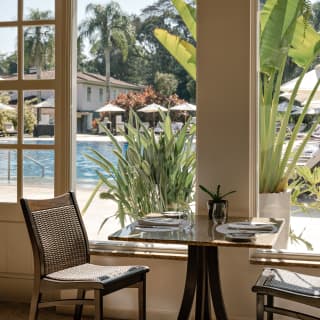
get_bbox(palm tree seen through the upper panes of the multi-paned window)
[24,9,54,79]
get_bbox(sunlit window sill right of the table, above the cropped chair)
[250,250,320,268]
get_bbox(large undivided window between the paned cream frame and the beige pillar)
[76,0,196,240]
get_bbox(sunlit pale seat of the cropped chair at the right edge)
[264,269,320,297]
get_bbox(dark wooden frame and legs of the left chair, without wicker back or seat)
[20,192,149,320]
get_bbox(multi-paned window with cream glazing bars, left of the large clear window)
[0,0,71,219]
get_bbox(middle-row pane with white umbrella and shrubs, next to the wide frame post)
[23,90,55,144]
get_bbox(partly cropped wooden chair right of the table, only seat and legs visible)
[252,269,320,320]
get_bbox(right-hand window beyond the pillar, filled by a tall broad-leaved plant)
[258,0,320,254]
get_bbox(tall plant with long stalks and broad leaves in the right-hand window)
[259,0,320,192]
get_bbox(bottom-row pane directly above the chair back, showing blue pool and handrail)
[23,150,54,199]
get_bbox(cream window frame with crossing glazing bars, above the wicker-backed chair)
[0,0,76,221]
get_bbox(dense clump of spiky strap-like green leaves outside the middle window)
[86,111,196,225]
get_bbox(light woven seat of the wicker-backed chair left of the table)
[46,263,149,284]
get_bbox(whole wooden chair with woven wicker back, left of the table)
[21,192,149,320]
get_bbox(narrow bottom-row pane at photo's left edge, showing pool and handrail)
[0,149,17,202]
